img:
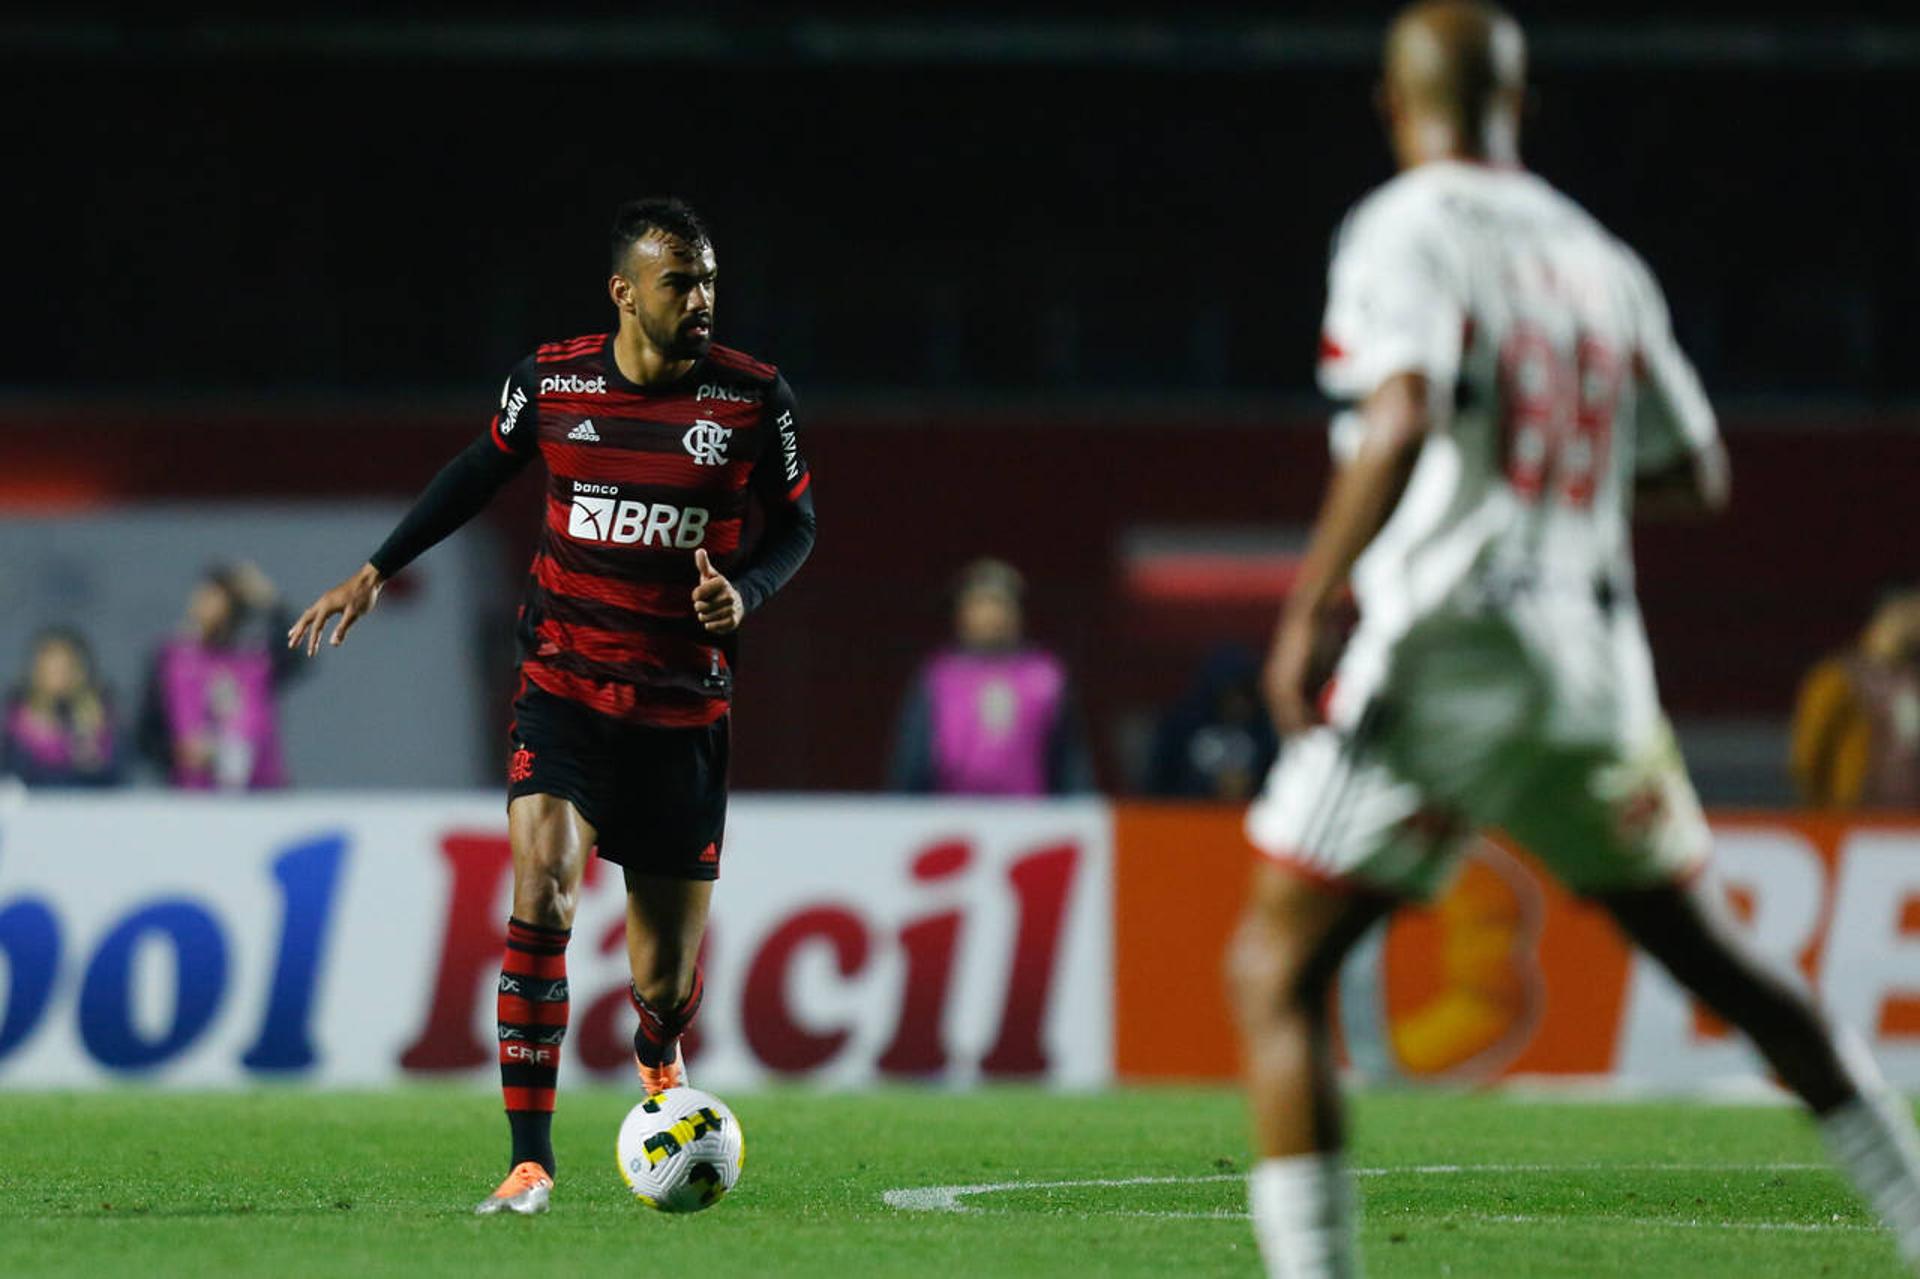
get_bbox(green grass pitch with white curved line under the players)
[0,1089,1901,1279]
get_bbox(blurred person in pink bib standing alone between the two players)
[891,559,1092,795]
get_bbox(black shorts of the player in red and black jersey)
[507,686,730,880]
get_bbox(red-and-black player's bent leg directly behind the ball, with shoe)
[626,870,714,1093]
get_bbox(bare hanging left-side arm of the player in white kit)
[1265,373,1430,734]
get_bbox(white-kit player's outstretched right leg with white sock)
[1601,885,1920,1264]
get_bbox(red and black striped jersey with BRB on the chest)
[490,334,812,728]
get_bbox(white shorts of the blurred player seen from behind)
[1246,606,1711,899]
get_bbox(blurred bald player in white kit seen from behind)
[1229,0,1920,1279]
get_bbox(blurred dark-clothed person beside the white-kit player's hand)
[1146,645,1281,801]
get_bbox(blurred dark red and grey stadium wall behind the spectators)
[15,409,1920,805]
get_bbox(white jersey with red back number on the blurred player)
[1319,163,1716,645]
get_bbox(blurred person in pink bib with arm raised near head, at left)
[140,563,300,791]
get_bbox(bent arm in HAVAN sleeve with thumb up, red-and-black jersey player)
[693,378,816,636]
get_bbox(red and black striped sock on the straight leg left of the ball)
[497,918,572,1177]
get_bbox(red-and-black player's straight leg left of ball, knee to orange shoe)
[476,795,595,1214]
